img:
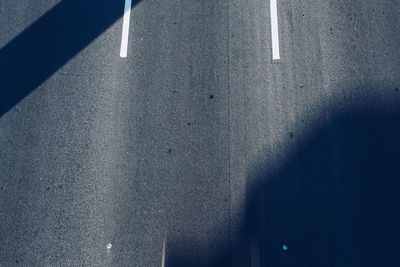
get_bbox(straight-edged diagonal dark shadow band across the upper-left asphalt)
[0,0,141,117]
